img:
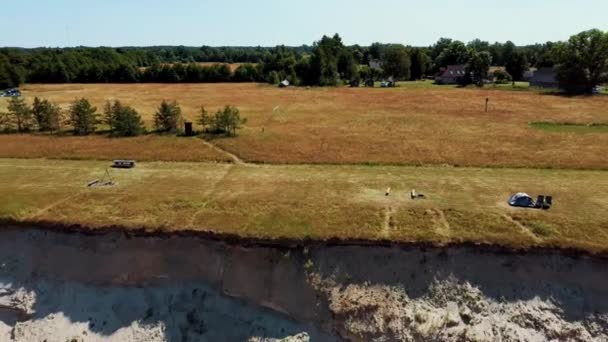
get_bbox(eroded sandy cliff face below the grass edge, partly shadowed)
[0,227,608,341]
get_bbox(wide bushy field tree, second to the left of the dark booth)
[104,101,145,137]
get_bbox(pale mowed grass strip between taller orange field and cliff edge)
[0,159,608,252]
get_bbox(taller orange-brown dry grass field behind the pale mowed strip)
[0,82,608,169]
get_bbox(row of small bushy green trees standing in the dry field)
[0,97,247,137]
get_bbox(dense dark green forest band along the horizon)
[0,30,608,91]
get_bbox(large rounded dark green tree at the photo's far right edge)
[554,29,608,93]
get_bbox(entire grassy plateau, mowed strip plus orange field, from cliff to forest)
[0,82,608,253]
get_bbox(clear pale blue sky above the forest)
[0,0,608,47]
